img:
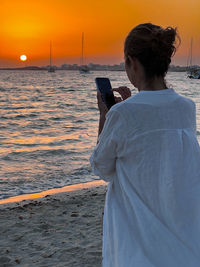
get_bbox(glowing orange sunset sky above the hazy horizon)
[0,0,200,67]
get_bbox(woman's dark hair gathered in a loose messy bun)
[124,23,180,80]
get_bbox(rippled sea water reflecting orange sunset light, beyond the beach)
[0,71,200,199]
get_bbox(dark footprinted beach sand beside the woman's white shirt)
[0,185,106,267]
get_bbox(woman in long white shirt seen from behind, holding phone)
[90,23,200,267]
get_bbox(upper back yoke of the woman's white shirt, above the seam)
[120,89,196,136]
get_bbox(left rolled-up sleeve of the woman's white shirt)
[90,110,123,182]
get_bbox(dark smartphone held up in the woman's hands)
[95,77,116,109]
